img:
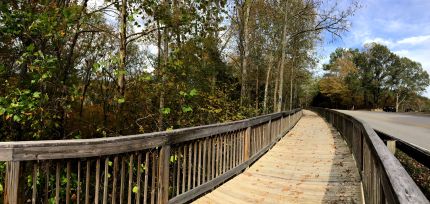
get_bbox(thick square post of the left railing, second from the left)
[157,145,170,204]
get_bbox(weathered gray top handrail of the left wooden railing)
[0,110,304,161]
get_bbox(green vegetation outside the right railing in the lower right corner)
[395,149,430,200]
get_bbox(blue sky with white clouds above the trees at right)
[320,0,430,98]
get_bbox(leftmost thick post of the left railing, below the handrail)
[4,161,20,204]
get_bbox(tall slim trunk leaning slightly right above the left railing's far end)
[277,1,288,112]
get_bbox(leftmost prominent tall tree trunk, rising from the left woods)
[118,0,127,97]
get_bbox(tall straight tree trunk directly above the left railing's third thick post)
[240,0,250,105]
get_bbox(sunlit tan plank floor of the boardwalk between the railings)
[195,111,362,204]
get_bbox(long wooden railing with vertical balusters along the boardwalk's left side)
[0,109,302,204]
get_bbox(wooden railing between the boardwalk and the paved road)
[313,108,429,204]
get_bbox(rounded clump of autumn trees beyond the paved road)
[314,44,430,110]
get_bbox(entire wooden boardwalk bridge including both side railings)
[0,109,428,204]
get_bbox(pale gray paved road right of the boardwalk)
[337,110,430,151]
